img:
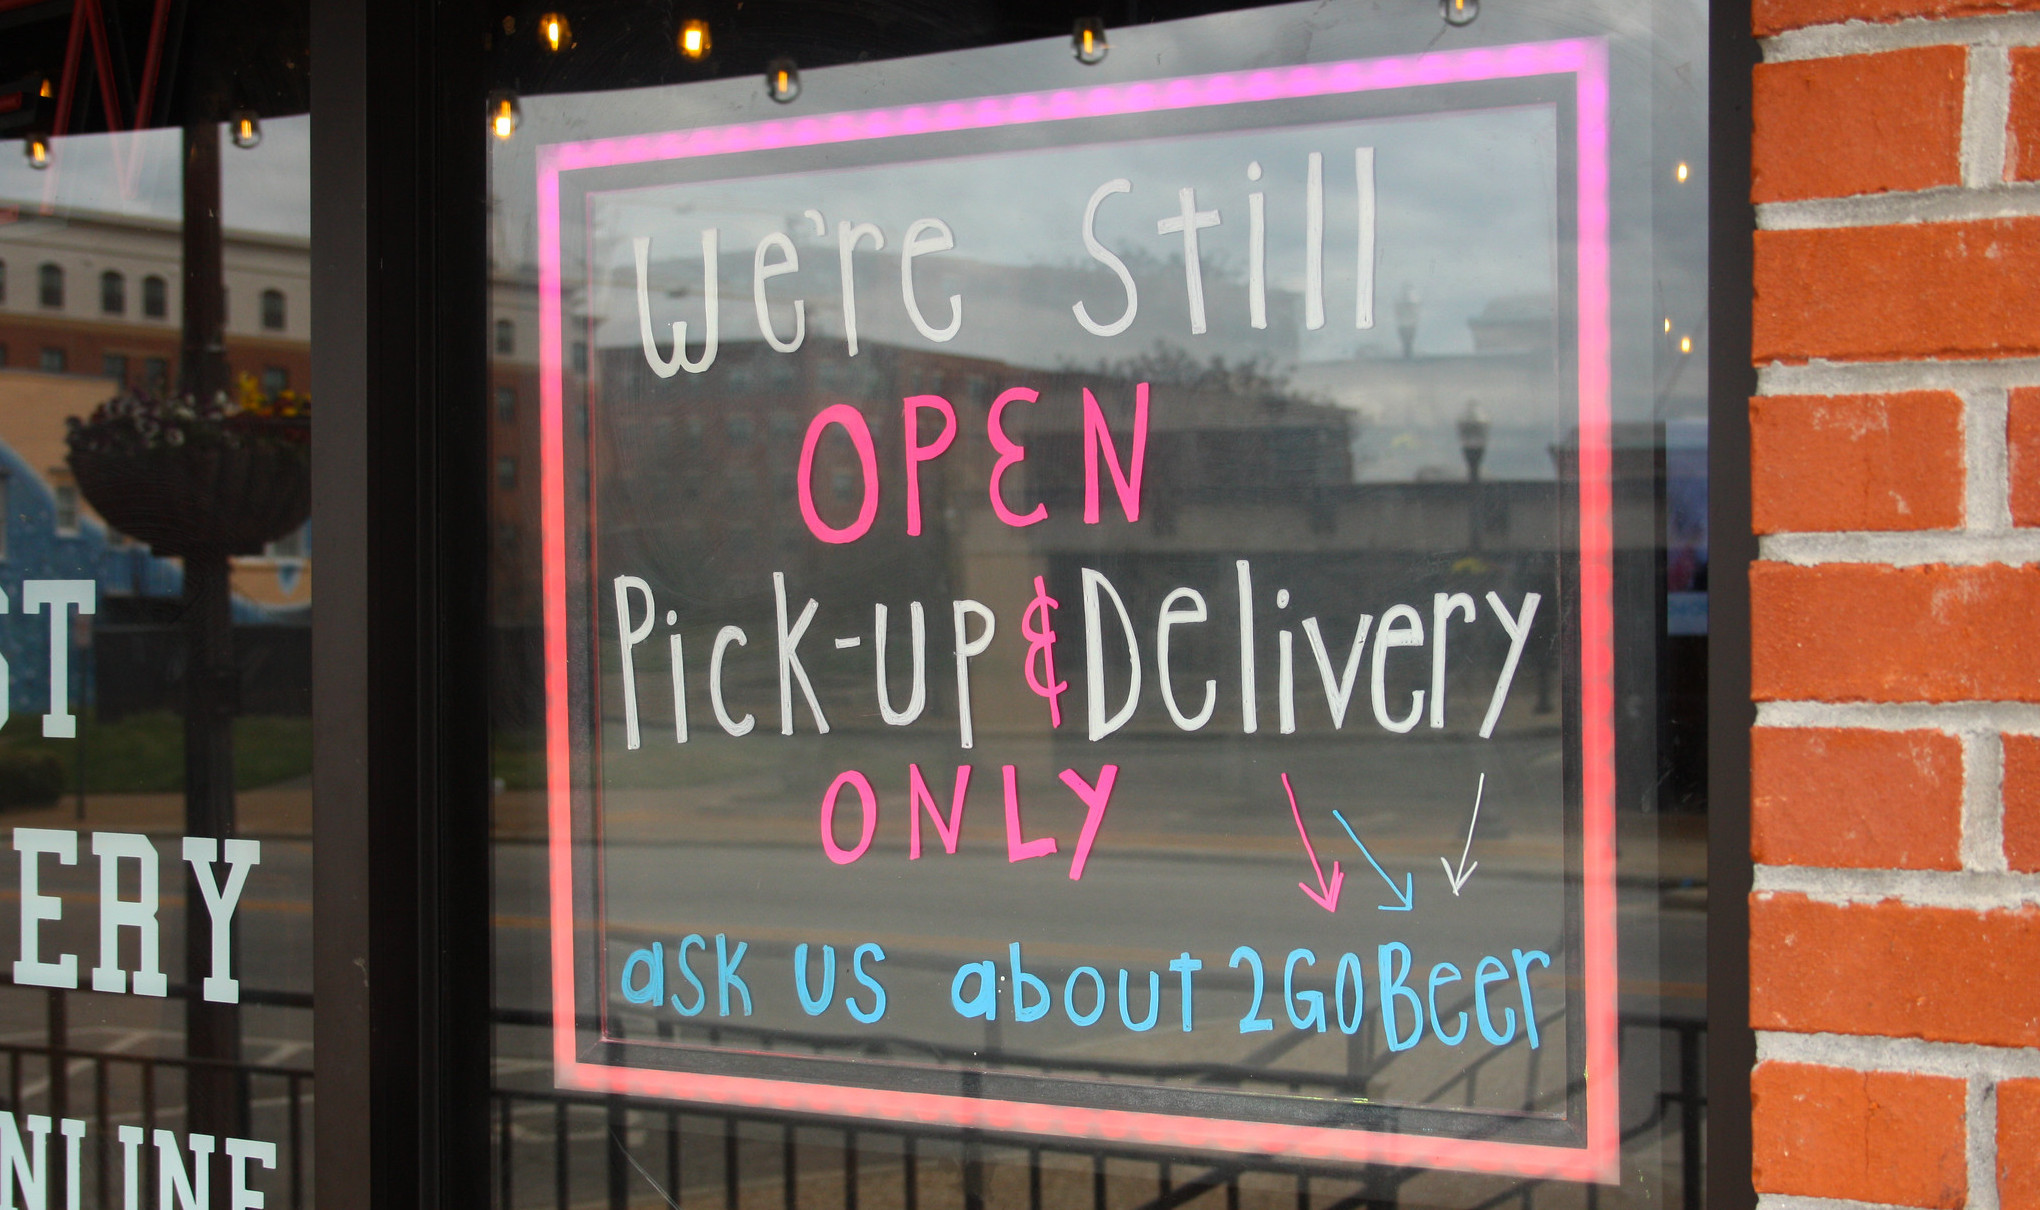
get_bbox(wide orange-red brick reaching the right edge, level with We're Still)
[1750,218,2040,363]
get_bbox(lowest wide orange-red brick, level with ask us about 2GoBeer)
[1750,894,2040,1047]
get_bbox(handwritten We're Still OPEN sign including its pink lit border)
[539,41,1616,1179]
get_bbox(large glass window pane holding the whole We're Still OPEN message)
[475,0,1707,1210]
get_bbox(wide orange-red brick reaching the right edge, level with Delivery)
[1750,563,2040,702]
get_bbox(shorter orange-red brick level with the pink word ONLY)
[1750,726,1962,869]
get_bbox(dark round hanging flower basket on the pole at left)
[65,380,312,555]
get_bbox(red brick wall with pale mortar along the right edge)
[1750,0,2040,1210]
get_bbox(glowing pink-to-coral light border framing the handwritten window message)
[539,39,1622,1183]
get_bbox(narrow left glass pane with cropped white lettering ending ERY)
[0,91,316,1208]
